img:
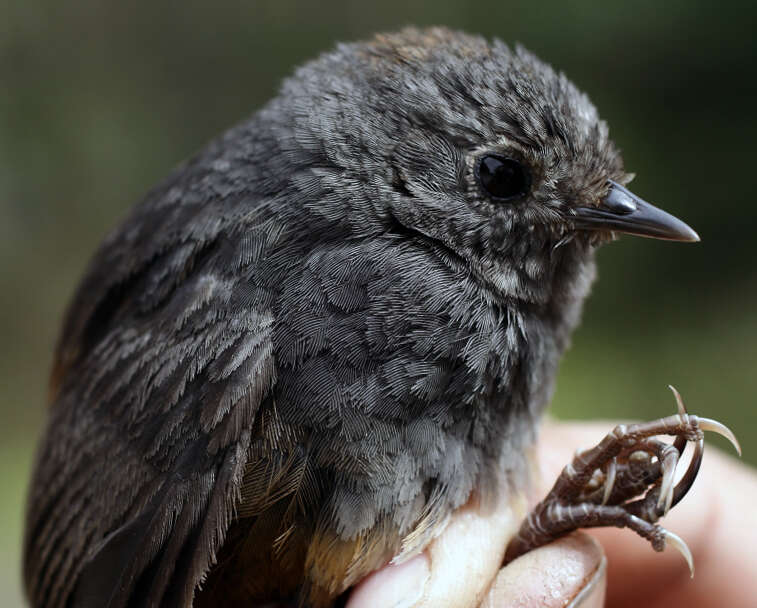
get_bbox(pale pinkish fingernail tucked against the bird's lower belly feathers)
[346,553,431,608]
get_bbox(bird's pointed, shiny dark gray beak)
[572,181,699,242]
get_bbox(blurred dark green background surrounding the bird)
[0,0,757,607]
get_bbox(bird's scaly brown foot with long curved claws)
[505,386,741,576]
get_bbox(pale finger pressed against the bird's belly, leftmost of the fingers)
[347,486,526,608]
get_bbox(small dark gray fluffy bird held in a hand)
[24,29,728,608]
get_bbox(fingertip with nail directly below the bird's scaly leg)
[482,532,607,608]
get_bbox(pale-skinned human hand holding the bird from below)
[347,422,757,608]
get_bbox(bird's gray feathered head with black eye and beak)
[268,28,698,303]
